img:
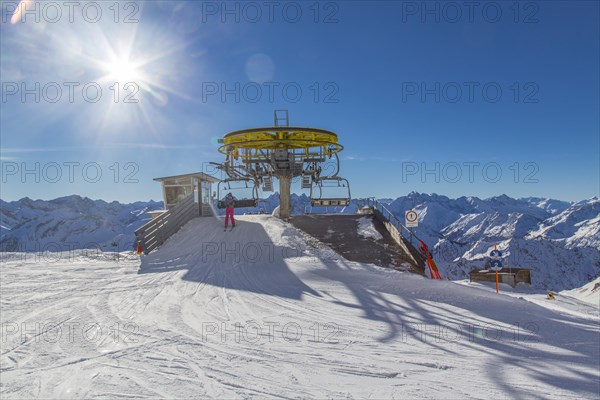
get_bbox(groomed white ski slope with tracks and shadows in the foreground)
[0,216,600,399]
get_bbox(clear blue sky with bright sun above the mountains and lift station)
[0,1,600,202]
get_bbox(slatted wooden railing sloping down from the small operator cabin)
[135,193,199,254]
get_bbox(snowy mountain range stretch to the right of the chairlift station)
[386,193,600,290]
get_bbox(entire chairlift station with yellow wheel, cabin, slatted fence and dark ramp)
[135,110,434,279]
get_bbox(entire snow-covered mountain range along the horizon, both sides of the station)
[0,193,600,290]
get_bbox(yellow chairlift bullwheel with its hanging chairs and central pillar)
[213,110,350,219]
